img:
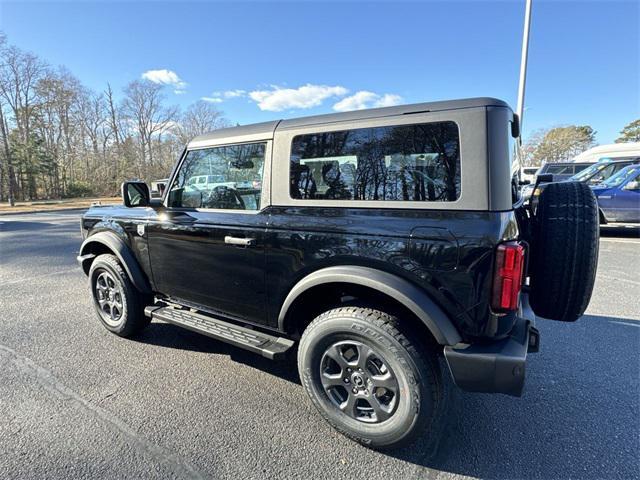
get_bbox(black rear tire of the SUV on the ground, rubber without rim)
[298,306,443,449]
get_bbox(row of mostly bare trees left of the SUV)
[0,33,228,205]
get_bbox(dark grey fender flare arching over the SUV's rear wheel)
[278,265,462,345]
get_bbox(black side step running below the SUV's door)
[144,305,293,360]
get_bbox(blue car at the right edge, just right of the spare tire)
[591,165,640,223]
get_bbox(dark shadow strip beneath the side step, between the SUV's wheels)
[133,321,300,384]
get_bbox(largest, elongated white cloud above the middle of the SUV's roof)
[249,83,349,112]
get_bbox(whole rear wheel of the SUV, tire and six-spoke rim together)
[298,307,442,448]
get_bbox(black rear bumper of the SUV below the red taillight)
[444,296,540,397]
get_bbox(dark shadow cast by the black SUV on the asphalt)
[136,315,640,479]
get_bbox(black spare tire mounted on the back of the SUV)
[529,182,600,322]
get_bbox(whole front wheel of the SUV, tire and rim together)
[89,254,150,337]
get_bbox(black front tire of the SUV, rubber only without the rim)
[89,254,151,337]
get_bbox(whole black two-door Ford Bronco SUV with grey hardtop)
[78,98,598,448]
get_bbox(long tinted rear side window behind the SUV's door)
[289,122,460,202]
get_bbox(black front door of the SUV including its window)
[147,142,268,323]
